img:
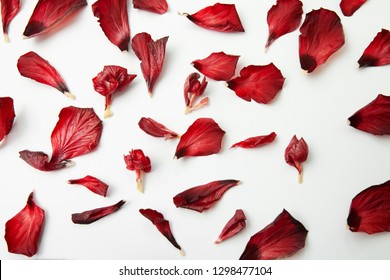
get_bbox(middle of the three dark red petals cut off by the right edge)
[348,94,390,135]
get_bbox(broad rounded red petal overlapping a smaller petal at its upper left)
[228,63,285,104]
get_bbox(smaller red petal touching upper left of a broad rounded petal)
[192,52,240,81]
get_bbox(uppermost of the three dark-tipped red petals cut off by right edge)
[358,29,390,67]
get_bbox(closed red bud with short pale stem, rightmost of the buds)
[284,135,309,183]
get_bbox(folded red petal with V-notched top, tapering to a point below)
[131,32,168,94]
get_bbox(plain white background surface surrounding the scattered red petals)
[0,0,390,260]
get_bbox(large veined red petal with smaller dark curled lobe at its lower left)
[20,106,103,171]
